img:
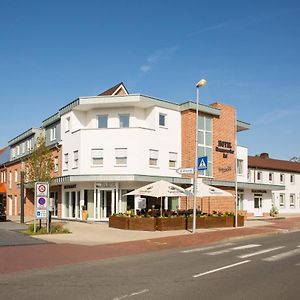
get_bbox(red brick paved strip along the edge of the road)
[0,218,300,273]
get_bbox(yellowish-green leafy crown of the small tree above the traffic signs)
[25,136,54,182]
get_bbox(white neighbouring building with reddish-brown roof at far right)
[248,153,300,214]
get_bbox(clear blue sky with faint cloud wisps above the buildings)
[0,0,300,159]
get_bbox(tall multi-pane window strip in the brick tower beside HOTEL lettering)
[197,115,213,176]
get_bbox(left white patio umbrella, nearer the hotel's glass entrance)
[124,180,186,215]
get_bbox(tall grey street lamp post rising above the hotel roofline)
[193,79,206,233]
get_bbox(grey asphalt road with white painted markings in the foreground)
[0,232,300,300]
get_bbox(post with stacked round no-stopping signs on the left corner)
[34,182,50,233]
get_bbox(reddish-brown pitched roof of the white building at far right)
[248,155,300,173]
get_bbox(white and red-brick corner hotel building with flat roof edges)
[1,83,264,221]
